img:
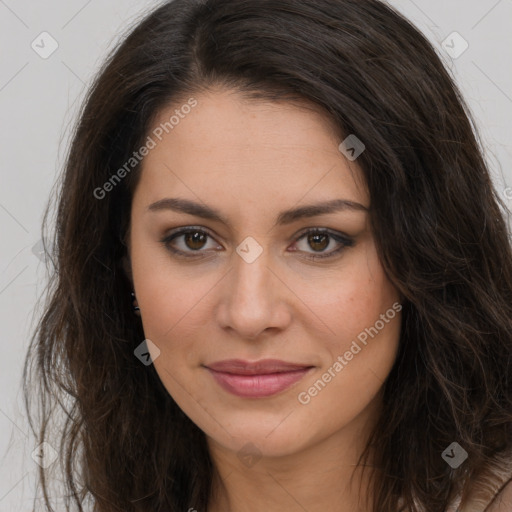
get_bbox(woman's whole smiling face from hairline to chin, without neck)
[129,90,401,456]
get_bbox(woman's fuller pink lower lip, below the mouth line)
[208,368,312,398]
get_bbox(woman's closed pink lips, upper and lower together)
[206,359,312,398]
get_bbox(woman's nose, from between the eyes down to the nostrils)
[217,250,291,340]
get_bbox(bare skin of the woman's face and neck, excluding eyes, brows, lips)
[128,89,401,512]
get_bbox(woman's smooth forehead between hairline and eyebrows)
[139,90,368,203]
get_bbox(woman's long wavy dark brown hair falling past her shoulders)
[24,0,512,512]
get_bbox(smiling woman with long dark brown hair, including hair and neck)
[26,0,512,512]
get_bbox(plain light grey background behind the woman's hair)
[0,0,512,512]
